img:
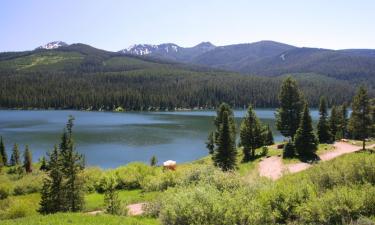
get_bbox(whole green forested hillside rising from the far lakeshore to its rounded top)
[0,44,374,110]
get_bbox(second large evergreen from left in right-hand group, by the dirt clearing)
[240,106,264,162]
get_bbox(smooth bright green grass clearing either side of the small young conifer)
[84,190,159,212]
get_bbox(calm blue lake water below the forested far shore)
[0,109,318,168]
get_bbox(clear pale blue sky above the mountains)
[0,0,375,51]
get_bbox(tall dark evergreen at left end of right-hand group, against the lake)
[213,111,237,171]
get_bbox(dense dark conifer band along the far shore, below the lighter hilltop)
[0,68,364,110]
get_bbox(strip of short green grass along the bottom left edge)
[1,213,160,225]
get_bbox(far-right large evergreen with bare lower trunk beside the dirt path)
[349,87,373,149]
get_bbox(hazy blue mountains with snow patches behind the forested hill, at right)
[120,41,375,80]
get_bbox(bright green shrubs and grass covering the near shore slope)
[0,141,375,225]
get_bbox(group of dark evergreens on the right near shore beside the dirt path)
[206,77,375,171]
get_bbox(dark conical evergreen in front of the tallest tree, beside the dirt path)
[294,104,318,158]
